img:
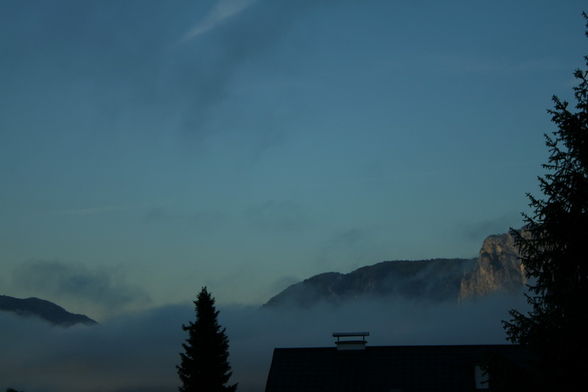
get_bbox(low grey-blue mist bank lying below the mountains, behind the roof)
[0,295,526,392]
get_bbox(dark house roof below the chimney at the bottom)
[266,345,527,392]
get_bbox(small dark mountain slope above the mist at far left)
[0,295,97,327]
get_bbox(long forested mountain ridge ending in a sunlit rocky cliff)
[264,234,526,307]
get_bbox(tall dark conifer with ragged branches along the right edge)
[504,13,588,390]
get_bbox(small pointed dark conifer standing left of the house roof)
[177,287,237,392]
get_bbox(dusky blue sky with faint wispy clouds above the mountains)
[0,0,586,320]
